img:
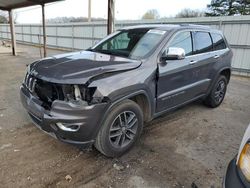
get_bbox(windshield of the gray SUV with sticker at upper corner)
[91,29,166,59]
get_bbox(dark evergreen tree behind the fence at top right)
[206,0,250,16]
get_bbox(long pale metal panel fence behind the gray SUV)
[0,16,250,76]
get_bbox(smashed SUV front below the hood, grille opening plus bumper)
[20,73,108,145]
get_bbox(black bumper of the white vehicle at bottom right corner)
[223,159,248,188]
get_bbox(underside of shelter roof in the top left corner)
[0,0,61,10]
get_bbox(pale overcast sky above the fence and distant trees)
[15,0,211,23]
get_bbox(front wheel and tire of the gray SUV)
[95,99,143,157]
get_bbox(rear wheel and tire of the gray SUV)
[204,75,228,108]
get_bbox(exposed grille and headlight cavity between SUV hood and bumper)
[24,73,108,110]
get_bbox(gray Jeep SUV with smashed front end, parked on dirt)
[20,24,232,157]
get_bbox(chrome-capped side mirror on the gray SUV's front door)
[161,47,185,61]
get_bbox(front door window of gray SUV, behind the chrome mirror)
[168,31,193,56]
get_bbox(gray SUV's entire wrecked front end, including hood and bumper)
[20,51,142,148]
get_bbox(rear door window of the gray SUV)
[193,31,213,54]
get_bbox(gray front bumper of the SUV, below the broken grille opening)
[20,85,107,147]
